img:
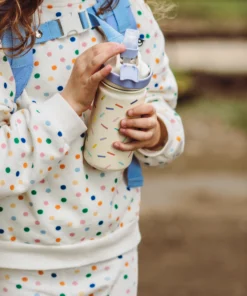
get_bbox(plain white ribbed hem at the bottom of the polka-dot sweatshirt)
[0,220,141,270]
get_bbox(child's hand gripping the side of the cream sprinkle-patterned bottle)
[113,104,167,151]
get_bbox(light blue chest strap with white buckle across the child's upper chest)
[36,0,137,44]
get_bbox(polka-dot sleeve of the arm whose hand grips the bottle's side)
[131,0,184,166]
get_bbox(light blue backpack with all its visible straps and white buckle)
[2,0,143,188]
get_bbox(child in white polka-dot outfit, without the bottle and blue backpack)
[0,0,184,296]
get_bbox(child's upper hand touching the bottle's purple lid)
[61,42,125,115]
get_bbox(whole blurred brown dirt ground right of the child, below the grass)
[138,108,247,296]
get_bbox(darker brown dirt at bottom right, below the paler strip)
[139,208,247,296]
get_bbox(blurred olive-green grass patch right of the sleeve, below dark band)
[178,98,247,135]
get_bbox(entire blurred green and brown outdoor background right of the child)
[139,0,247,296]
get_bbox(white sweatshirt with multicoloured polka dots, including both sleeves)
[0,0,184,269]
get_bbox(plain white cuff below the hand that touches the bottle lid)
[43,93,87,143]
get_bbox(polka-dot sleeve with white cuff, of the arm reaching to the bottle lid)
[0,51,87,198]
